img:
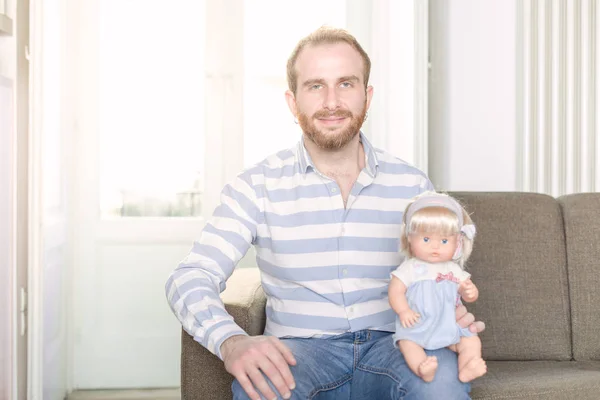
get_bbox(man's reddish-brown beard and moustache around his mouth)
[298,102,367,150]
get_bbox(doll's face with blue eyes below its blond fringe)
[408,232,458,263]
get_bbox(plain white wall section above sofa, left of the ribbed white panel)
[429,0,517,191]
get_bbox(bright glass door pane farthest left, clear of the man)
[98,0,205,216]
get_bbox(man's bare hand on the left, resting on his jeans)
[221,335,296,400]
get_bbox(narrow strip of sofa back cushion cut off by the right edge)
[558,193,600,361]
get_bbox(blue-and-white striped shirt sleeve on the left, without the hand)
[165,175,260,359]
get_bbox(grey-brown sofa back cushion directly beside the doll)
[449,192,572,360]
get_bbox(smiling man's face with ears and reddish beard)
[286,43,373,150]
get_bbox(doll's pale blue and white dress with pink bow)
[392,258,475,350]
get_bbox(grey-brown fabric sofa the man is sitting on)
[181,192,600,400]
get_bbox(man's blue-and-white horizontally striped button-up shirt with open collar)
[166,134,433,357]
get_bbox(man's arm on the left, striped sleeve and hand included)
[165,175,296,399]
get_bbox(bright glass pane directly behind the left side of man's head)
[244,0,347,166]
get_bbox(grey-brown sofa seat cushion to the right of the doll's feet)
[471,361,600,400]
